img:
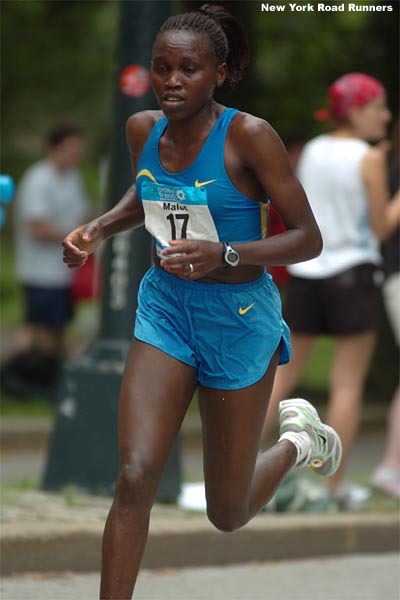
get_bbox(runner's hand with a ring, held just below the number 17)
[160,239,223,279]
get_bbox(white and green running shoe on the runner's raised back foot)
[278,398,342,477]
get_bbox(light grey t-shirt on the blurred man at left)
[15,160,88,287]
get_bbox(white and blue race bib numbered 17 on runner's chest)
[142,181,219,256]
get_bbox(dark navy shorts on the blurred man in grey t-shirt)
[24,285,74,329]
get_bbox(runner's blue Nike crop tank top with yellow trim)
[136,108,267,251]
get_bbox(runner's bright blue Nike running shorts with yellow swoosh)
[134,266,291,390]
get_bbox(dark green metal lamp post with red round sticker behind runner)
[43,0,181,500]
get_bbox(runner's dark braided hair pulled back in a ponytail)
[158,4,250,84]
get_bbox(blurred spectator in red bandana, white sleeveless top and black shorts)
[264,73,400,509]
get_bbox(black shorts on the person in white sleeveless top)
[283,264,383,335]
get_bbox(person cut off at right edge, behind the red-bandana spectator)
[371,121,400,498]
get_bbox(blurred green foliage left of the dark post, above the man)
[1,0,118,175]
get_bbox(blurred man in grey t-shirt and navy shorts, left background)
[1,124,88,396]
